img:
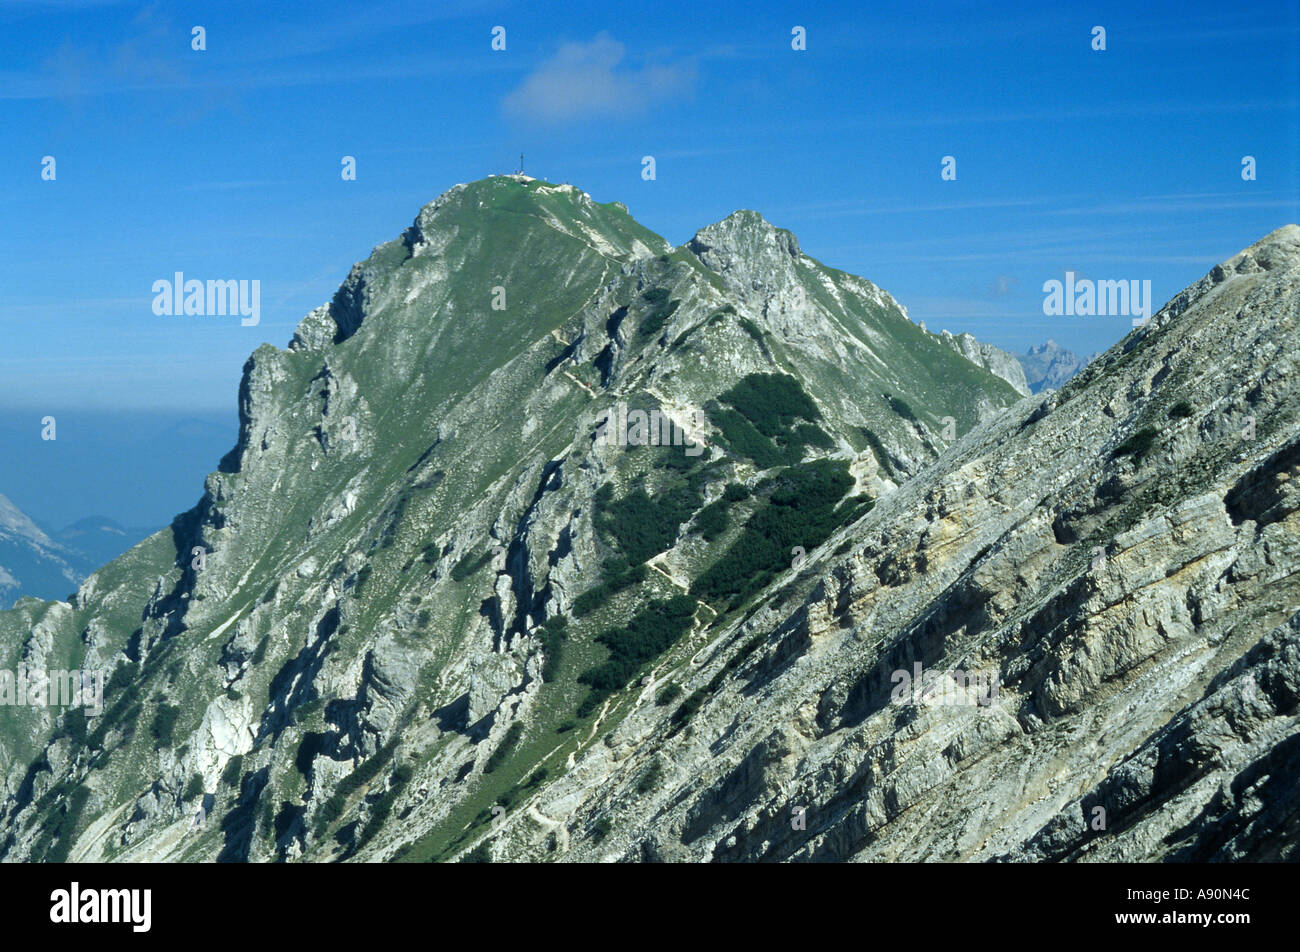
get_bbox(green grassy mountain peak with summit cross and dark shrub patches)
[0,176,1017,861]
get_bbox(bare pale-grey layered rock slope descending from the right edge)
[478,226,1300,861]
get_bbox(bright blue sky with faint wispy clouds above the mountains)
[0,0,1300,416]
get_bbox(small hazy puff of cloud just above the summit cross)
[502,31,696,122]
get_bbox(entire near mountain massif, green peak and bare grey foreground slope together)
[0,176,1300,861]
